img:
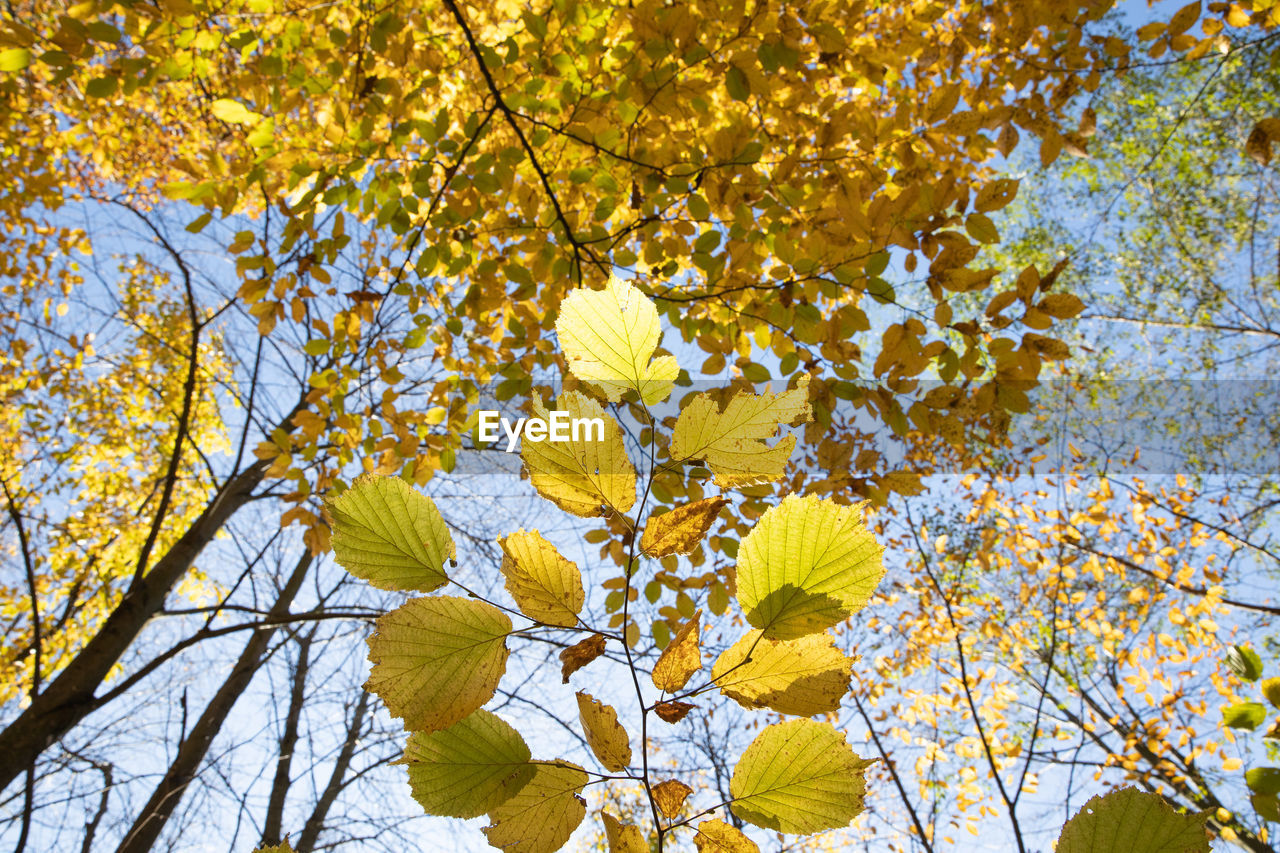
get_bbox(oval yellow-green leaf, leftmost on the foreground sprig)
[328,476,458,592]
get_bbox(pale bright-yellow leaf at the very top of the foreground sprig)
[556,278,680,405]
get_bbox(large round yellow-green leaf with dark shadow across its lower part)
[737,494,884,639]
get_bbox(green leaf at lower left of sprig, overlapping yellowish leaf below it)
[401,711,534,818]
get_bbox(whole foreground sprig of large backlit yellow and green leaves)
[329,282,883,853]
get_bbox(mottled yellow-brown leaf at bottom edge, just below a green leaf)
[484,761,588,853]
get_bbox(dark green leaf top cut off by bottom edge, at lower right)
[1056,788,1210,853]
